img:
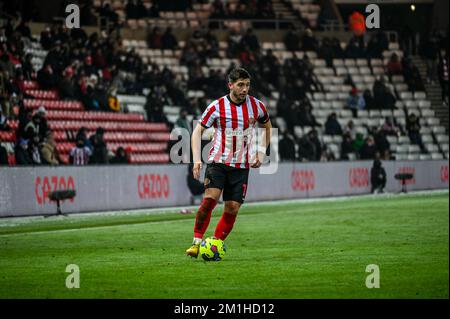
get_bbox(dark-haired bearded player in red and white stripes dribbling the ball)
[186,68,272,257]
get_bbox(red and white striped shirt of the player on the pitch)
[201,95,269,168]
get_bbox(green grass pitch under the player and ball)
[0,191,449,299]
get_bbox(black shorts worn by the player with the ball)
[205,163,250,204]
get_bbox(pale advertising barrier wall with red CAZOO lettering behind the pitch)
[0,160,448,217]
